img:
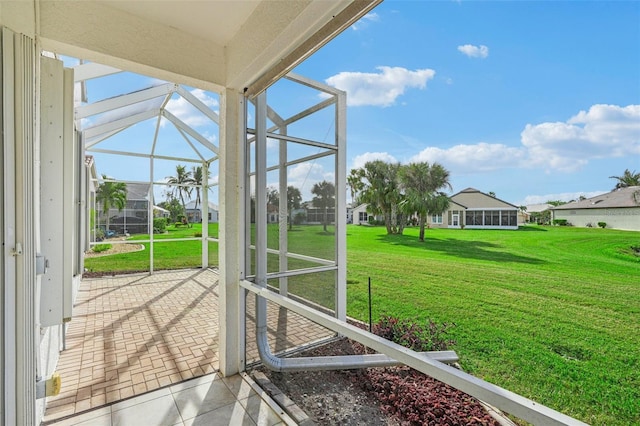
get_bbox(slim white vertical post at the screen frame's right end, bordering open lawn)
[335,92,347,321]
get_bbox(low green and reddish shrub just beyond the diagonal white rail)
[373,316,456,352]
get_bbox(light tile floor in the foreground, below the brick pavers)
[47,373,295,426]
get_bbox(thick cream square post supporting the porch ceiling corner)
[218,89,246,376]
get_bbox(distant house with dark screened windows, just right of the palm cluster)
[427,188,519,229]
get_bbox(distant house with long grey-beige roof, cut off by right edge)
[552,186,640,231]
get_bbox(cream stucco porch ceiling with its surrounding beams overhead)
[36,0,381,93]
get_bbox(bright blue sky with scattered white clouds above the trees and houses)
[74,0,640,205]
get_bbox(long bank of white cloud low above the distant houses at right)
[402,105,640,173]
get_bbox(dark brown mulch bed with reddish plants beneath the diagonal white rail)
[258,339,499,426]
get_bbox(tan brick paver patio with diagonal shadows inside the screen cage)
[44,270,332,422]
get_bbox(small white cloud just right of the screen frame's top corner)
[325,66,436,107]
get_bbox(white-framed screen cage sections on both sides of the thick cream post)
[80,63,346,317]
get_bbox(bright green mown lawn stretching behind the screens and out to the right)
[86,224,640,425]
